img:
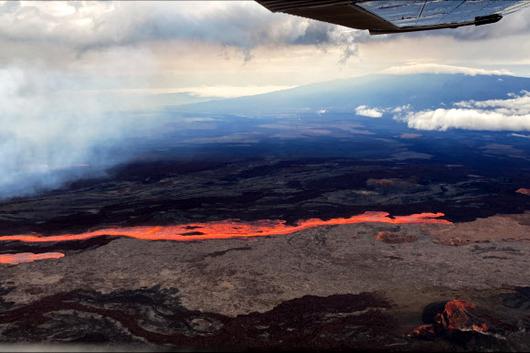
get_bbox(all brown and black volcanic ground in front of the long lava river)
[0,214,530,350]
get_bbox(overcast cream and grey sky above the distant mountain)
[0,1,530,102]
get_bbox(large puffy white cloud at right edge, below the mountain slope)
[401,92,530,131]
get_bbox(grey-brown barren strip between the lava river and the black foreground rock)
[3,220,530,315]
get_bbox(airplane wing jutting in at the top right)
[257,0,530,34]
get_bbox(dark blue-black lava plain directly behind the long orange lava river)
[0,158,530,234]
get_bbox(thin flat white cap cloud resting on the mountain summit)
[383,63,513,76]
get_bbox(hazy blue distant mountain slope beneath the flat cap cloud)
[177,74,530,115]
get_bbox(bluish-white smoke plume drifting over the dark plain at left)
[0,65,160,199]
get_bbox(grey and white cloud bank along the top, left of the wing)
[0,1,368,61]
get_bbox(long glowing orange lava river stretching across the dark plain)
[0,212,451,243]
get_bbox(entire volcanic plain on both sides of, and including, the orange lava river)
[0,159,530,351]
